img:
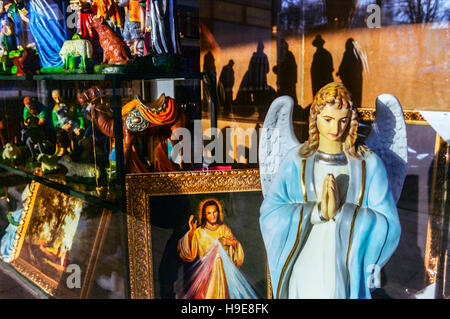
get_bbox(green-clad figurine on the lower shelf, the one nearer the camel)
[52,90,84,156]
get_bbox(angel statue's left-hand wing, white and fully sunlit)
[259,96,300,196]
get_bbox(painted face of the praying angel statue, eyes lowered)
[317,104,350,142]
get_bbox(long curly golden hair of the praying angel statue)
[300,82,365,158]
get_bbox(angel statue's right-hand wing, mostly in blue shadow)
[365,94,408,202]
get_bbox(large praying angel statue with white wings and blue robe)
[259,82,407,299]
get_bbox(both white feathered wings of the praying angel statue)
[259,94,408,202]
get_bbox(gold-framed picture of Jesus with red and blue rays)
[126,169,270,299]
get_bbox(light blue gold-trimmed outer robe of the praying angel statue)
[260,148,401,298]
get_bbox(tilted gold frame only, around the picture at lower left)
[11,182,111,299]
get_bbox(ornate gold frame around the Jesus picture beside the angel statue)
[125,169,264,299]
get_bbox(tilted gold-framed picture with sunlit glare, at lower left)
[11,182,111,298]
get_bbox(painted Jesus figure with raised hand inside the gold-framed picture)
[178,200,244,299]
